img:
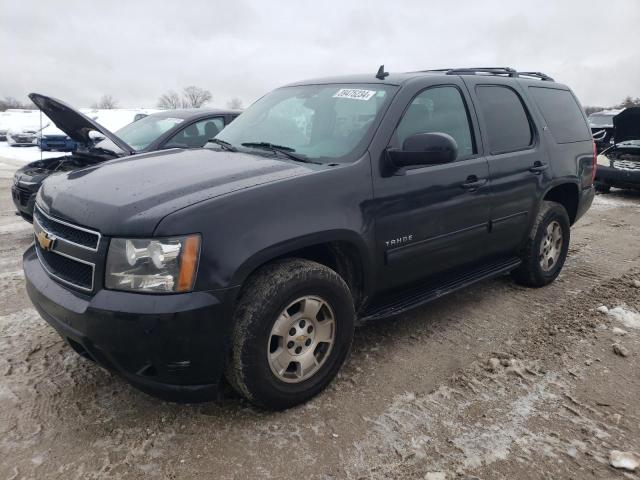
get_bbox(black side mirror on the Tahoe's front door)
[387,132,458,167]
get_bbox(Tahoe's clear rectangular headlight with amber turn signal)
[105,235,200,293]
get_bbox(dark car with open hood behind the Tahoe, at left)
[12,93,239,221]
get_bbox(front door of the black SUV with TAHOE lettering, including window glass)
[374,85,490,290]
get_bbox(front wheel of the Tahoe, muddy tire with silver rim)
[226,259,355,410]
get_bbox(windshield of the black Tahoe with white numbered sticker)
[216,84,396,162]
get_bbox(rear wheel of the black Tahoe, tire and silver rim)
[511,201,571,288]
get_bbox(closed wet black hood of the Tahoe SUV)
[38,149,312,236]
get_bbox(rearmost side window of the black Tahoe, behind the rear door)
[529,87,591,143]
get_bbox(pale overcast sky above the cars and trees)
[0,0,640,107]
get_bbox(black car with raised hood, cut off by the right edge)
[596,107,640,192]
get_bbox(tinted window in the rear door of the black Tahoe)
[476,85,533,155]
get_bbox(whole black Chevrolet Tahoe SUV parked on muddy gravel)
[24,68,595,409]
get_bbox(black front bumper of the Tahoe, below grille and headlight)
[23,246,237,401]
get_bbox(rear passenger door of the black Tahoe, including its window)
[464,77,551,254]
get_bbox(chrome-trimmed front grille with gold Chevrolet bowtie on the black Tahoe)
[33,205,101,292]
